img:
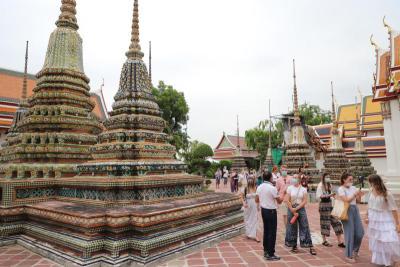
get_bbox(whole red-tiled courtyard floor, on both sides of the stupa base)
[0,181,388,267]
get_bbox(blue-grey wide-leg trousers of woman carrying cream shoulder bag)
[342,205,364,258]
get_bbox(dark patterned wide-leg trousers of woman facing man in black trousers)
[285,208,313,248]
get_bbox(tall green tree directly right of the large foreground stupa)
[152,81,189,154]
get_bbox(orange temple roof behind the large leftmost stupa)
[0,68,107,129]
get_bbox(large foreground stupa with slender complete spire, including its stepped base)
[0,0,243,266]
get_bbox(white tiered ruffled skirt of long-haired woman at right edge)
[368,209,400,266]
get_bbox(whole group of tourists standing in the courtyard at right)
[230,166,400,266]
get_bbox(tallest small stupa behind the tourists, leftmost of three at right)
[282,59,319,184]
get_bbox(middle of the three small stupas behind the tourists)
[322,82,350,185]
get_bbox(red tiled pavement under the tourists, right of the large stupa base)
[162,181,375,267]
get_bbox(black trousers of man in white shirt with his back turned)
[261,208,277,256]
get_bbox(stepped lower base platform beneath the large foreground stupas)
[0,193,243,266]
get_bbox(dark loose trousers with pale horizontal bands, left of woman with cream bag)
[319,201,343,236]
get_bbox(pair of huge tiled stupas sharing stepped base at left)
[0,0,243,266]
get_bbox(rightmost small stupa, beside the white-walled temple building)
[348,101,376,180]
